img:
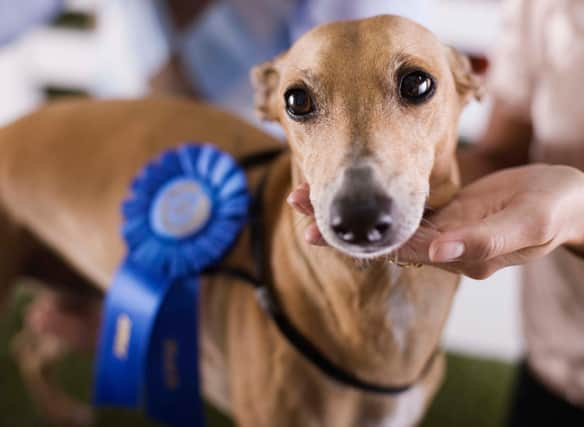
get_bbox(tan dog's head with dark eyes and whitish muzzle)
[252,16,479,258]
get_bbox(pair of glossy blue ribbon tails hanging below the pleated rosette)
[94,260,204,427]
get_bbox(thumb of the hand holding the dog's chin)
[429,206,547,263]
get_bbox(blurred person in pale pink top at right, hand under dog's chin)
[289,0,584,427]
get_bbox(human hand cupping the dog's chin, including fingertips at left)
[288,165,584,279]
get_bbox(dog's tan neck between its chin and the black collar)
[271,157,454,383]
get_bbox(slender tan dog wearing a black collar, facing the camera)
[0,16,480,427]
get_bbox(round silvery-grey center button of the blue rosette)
[150,178,212,239]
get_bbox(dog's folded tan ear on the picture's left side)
[250,57,280,121]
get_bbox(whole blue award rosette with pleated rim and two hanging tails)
[95,144,250,427]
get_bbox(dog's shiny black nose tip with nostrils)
[330,192,392,246]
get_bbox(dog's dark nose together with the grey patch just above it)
[330,169,392,247]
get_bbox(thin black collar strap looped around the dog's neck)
[207,149,438,395]
